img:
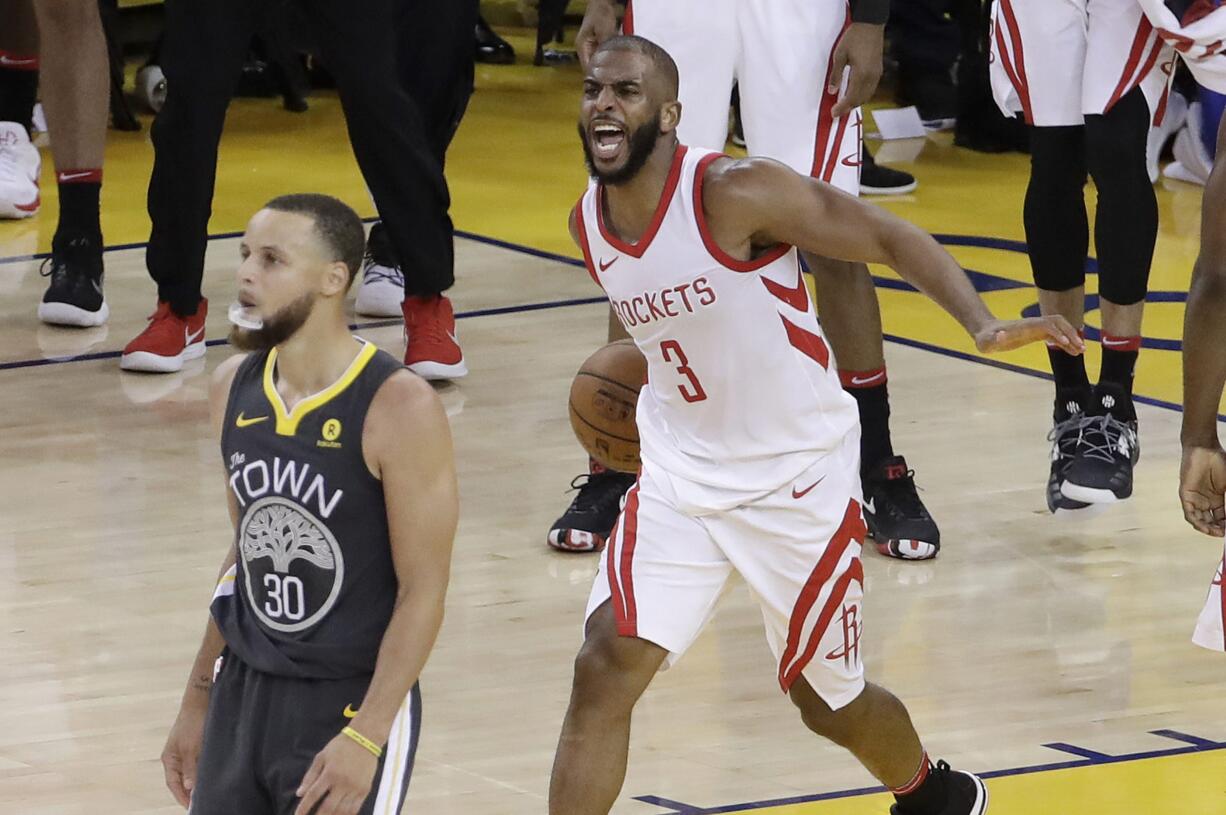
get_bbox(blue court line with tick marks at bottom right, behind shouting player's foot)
[634,730,1226,815]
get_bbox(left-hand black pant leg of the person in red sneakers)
[145,0,253,315]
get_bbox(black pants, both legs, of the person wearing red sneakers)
[146,0,472,315]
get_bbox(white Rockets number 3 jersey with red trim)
[575,146,858,511]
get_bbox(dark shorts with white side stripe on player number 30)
[191,651,422,815]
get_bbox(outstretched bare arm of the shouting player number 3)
[702,158,1083,353]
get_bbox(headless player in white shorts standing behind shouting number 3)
[549,0,940,560]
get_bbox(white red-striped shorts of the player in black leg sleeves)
[991,0,1175,127]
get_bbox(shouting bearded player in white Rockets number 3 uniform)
[549,37,1080,815]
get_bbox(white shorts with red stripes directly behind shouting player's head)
[624,0,862,195]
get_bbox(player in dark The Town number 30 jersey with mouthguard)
[162,195,457,815]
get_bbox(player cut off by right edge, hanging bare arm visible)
[1179,112,1226,651]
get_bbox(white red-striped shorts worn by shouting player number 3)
[587,434,866,710]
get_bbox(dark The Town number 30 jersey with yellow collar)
[212,342,402,679]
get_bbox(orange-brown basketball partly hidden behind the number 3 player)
[570,339,647,473]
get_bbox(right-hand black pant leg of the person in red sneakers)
[303,0,455,297]
